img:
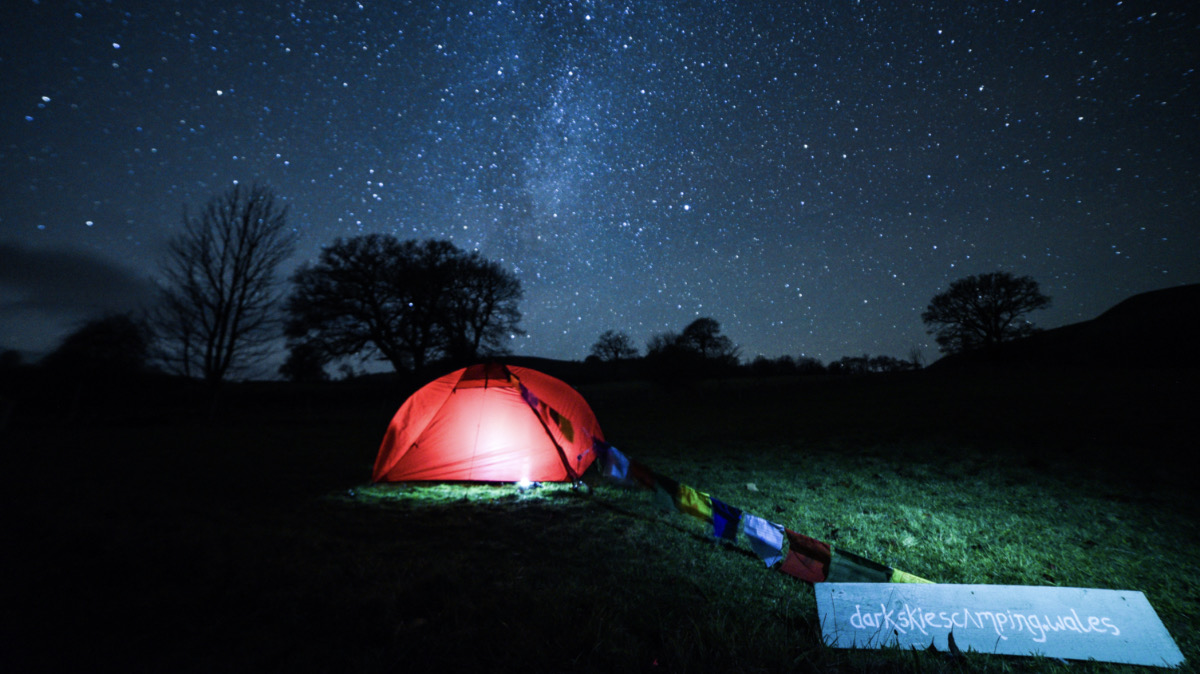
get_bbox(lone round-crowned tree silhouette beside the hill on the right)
[920,271,1050,354]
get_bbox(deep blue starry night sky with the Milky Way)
[0,0,1200,362]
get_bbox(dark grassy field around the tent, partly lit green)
[0,372,1200,673]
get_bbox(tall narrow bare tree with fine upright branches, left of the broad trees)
[154,185,296,385]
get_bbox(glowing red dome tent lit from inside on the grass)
[372,363,604,482]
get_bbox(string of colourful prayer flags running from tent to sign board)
[595,438,929,583]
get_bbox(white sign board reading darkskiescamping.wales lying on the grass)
[814,583,1183,667]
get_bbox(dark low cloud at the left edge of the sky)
[0,241,155,353]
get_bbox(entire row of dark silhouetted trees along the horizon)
[2,185,1050,386]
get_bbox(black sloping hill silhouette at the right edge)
[930,284,1200,368]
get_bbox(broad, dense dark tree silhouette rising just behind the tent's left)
[287,234,521,372]
